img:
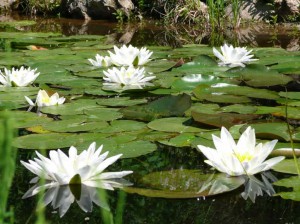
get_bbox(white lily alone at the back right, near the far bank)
[213,44,258,67]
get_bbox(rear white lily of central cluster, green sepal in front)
[108,45,153,66]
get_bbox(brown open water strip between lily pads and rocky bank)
[0,12,300,51]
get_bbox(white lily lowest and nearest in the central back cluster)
[103,66,155,85]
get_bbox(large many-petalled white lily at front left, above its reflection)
[21,142,132,189]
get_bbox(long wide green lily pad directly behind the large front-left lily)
[13,133,157,158]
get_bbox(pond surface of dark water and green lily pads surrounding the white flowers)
[0,15,300,224]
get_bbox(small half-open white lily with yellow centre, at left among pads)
[25,90,66,107]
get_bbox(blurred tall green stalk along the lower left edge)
[0,111,17,223]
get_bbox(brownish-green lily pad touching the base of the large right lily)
[124,170,244,198]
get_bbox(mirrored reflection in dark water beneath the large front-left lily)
[22,178,131,217]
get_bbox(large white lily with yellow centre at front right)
[198,127,284,176]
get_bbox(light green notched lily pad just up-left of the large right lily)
[148,117,206,133]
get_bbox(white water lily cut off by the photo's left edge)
[0,66,40,87]
